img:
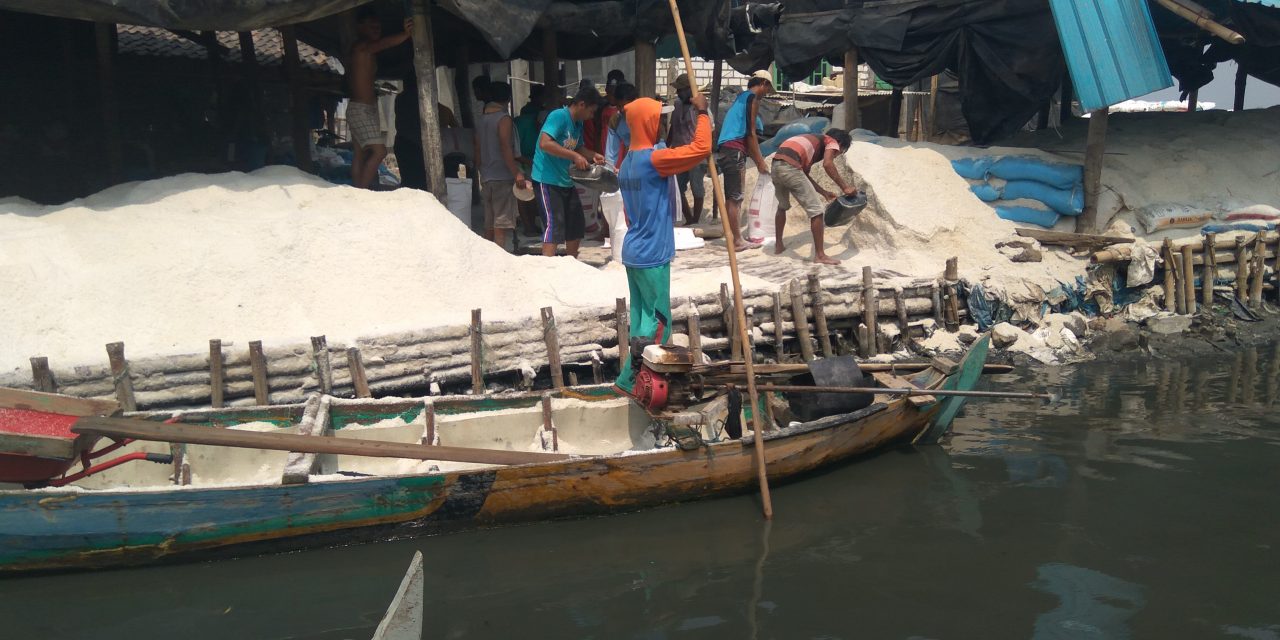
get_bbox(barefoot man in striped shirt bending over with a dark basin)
[771,129,856,265]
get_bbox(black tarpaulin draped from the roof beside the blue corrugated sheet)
[773,0,1064,143]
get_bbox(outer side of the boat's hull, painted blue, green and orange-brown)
[0,401,921,575]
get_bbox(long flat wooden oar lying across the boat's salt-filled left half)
[72,417,572,465]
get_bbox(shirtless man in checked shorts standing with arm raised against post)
[346,5,413,189]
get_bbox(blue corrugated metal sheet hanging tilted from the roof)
[1050,0,1174,111]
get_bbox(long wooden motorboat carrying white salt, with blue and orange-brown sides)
[0,338,987,575]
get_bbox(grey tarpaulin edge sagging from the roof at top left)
[0,0,369,31]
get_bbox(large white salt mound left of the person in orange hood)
[0,166,763,371]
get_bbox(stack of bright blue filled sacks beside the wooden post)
[951,156,1084,228]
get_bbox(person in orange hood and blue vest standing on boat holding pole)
[617,93,712,394]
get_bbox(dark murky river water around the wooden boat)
[0,347,1280,640]
